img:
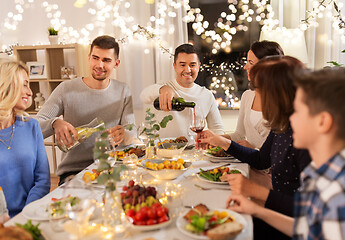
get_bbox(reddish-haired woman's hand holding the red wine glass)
[195,130,231,150]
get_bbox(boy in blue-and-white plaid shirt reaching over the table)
[227,68,345,240]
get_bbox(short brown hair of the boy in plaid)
[295,67,345,141]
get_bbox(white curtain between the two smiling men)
[114,0,188,116]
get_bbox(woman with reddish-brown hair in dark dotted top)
[198,56,311,239]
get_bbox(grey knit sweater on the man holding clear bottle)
[35,78,136,175]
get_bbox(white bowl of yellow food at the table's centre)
[142,158,192,180]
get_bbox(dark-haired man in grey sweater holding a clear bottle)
[35,36,136,184]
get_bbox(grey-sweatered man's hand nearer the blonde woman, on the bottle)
[53,119,78,147]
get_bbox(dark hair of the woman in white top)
[250,40,284,59]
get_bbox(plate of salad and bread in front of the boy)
[176,204,248,240]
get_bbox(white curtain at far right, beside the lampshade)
[271,0,345,69]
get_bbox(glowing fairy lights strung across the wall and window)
[1,0,345,108]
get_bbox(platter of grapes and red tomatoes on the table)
[121,180,171,231]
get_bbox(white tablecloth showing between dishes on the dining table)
[5,154,253,240]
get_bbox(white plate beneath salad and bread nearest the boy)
[176,208,248,240]
